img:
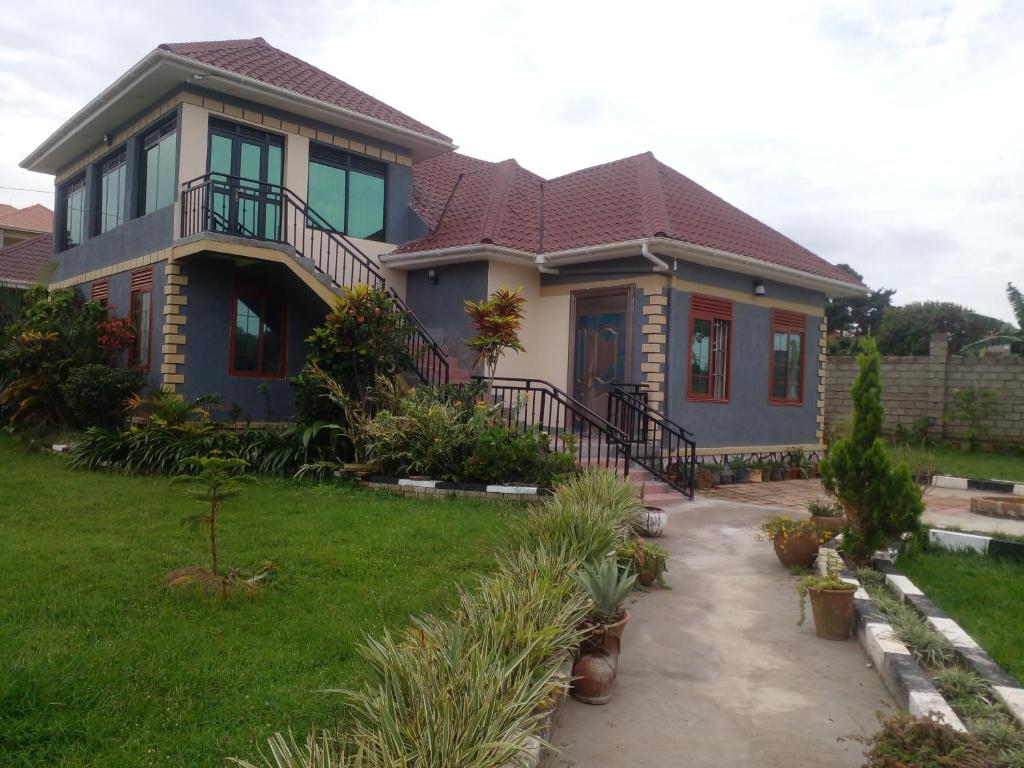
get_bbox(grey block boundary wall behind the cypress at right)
[825,334,1024,445]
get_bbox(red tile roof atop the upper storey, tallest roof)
[159,37,452,143]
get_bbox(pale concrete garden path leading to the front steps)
[544,500,893,768]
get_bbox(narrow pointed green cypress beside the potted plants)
[819,338,925,559]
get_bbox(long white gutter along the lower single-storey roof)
[381,238,867,296]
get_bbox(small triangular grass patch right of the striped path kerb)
[898,550,1024,682]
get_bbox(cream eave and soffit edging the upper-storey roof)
[19,48,457,174]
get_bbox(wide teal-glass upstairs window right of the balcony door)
[307,144,387,241]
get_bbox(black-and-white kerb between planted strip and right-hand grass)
[874,558,1024,727]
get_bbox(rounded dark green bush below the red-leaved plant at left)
[60,362,146,427]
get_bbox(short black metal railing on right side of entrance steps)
[607,384,697,499]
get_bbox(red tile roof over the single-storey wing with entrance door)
[398,152,861,286]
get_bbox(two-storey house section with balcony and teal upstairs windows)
[22,38,454,419]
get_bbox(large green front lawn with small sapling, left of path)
[0,437,503,768]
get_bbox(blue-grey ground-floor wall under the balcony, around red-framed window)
[179,258,328,421]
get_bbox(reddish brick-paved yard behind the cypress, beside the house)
[701,480,1024,535]
